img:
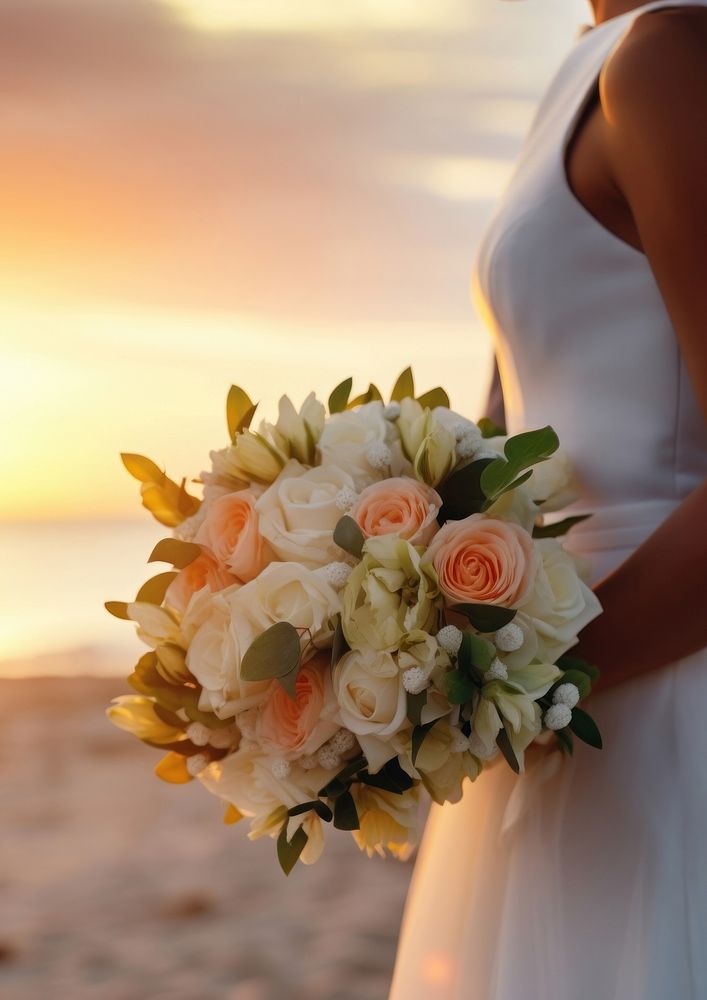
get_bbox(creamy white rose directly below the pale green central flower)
[333,650,407,771]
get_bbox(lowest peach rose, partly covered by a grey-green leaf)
[256,653,339,757]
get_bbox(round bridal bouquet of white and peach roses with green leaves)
[106,369,601,873]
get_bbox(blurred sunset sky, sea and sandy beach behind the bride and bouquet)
[0,0,589,1000]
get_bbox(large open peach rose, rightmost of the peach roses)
[425,514,537,608]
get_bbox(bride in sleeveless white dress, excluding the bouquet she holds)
[391,0,707,1000]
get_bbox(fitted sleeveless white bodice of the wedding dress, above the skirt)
[473,0,707,564]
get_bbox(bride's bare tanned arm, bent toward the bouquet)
[577,13,707,687]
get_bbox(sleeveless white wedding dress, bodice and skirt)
[391,0,707,1000]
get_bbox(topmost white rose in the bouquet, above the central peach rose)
[319,401,392,490]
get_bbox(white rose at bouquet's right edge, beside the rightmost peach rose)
[522,538,601,663]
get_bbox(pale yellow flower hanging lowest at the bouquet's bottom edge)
[351,784,419,860]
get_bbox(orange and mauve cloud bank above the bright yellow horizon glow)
[0,0,588,323]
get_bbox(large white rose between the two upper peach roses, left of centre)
[255,461,354,568]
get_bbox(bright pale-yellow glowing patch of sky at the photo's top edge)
[161,0,468,31]
